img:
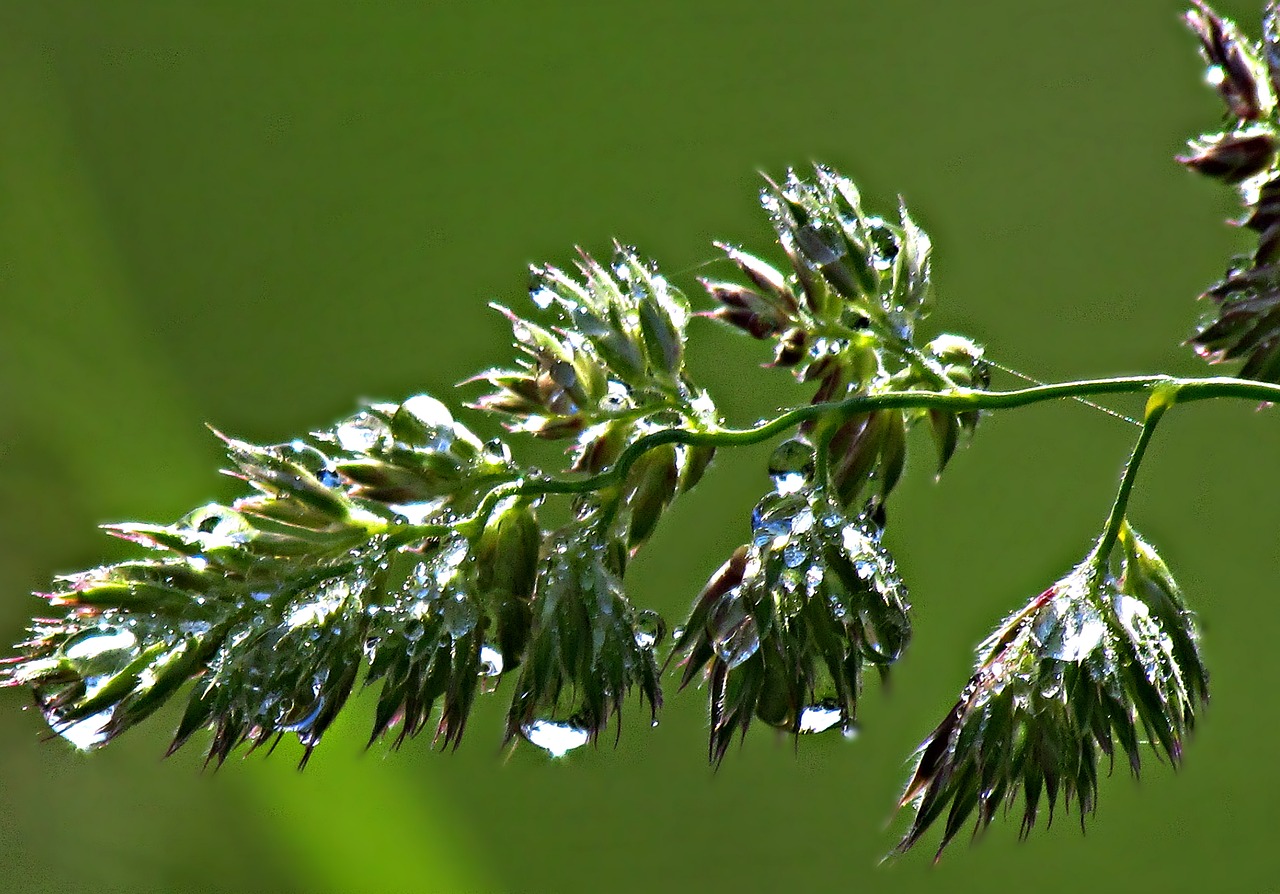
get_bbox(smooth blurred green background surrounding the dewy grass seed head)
[0,0,1280,894]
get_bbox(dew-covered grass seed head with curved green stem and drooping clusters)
[0,4,1280,852]
